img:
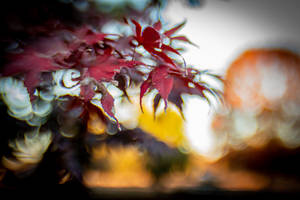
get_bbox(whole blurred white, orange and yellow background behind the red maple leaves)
[0,0,300,198]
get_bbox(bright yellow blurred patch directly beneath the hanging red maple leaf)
[138,107,187,147]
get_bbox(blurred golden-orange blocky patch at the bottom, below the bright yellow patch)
[84,146,153,188]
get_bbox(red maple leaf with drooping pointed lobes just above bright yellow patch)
[140,65,222,112]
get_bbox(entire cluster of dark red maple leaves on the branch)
[1,19,218,128]
